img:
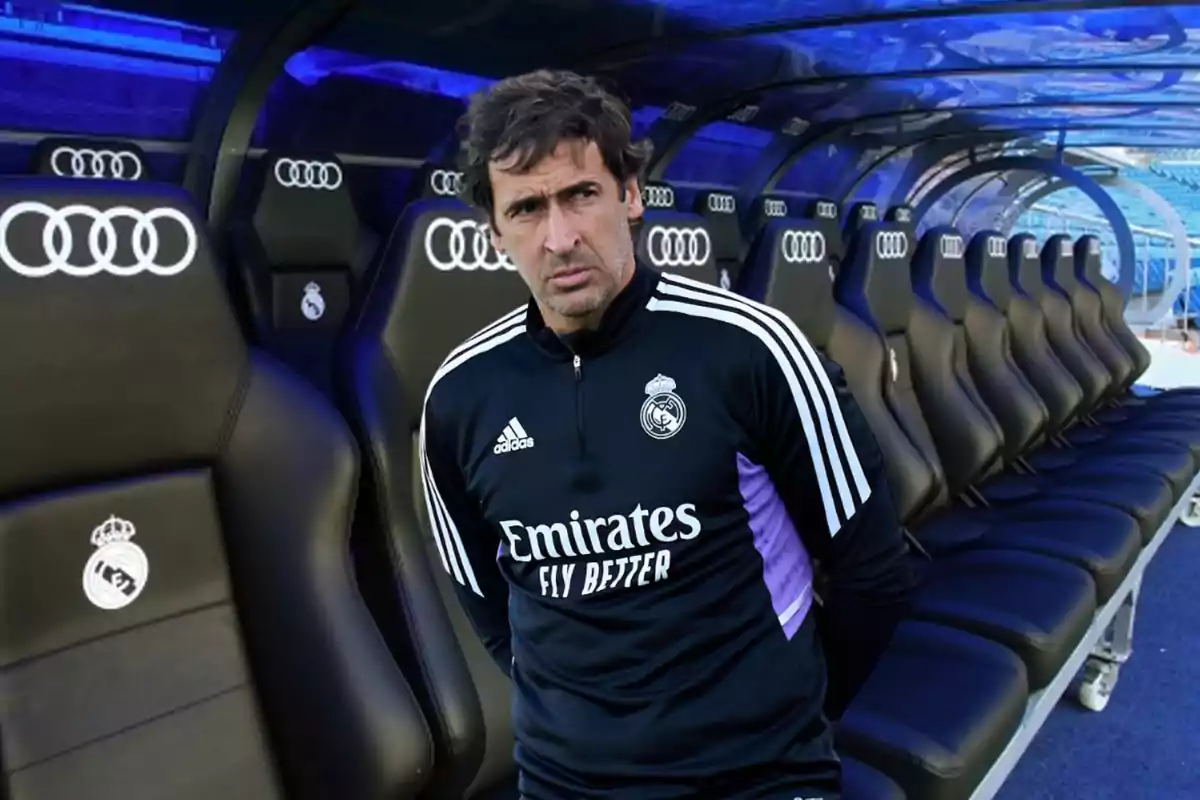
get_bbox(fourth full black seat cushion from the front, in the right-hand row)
[979,470,1175,541]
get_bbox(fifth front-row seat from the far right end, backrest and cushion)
[908,227,1176,544]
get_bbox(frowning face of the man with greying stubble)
[488,140,642,333]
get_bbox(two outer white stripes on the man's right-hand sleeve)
[659,268,871,506]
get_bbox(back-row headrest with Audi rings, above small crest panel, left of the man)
[253,152,360,270]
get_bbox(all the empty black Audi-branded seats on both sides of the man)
[0,137,1200,800]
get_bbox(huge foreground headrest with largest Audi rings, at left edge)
[0,178,247,497]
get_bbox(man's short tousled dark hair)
[460,70,653,217]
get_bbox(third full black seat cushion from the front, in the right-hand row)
[916,498,1142,602]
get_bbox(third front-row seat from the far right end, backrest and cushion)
[1008,234,1200,474]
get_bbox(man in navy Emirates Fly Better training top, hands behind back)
[421,72,911,800]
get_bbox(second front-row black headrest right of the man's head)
[752,219,835,348]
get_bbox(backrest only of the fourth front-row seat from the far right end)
[960,230,1050,462]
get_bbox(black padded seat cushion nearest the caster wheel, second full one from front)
[911,549,1097,690]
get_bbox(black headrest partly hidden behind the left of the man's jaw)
[358,199,529,425]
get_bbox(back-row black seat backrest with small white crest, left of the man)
[230,151,366,393]
